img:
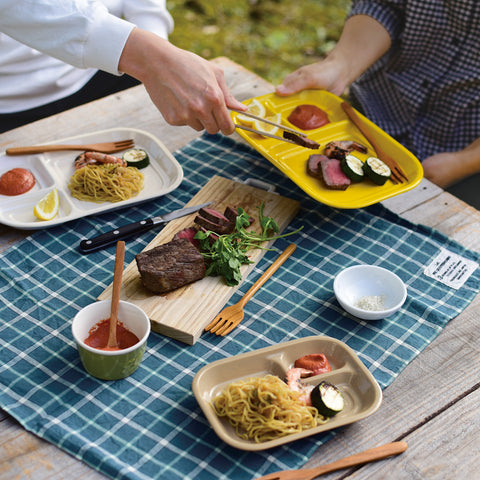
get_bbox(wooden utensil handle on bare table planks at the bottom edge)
[253,442,408,480]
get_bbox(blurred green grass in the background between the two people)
[167,0,350,84]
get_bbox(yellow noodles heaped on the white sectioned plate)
[68,164,143,203]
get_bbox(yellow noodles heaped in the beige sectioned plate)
[213,375,327,443]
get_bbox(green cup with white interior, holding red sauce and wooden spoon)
[72,300,150,380]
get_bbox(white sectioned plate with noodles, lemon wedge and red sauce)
[0,128,183,230]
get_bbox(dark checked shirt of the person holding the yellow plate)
[348,0,480,160]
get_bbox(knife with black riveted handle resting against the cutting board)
[80,202,213,253]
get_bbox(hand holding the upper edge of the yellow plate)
[275,58,347,96]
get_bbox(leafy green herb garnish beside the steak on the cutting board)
[195,203,302,286]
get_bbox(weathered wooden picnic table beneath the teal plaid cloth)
[0,58,480,480]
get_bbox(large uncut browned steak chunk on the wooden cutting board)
[135,238,205,293]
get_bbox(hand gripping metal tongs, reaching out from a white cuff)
[119,29,246,135]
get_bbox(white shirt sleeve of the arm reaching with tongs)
[0,0,173,75]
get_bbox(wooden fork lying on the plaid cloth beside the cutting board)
[205,243,297,337]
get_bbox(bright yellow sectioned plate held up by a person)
[232,90,423,208]
